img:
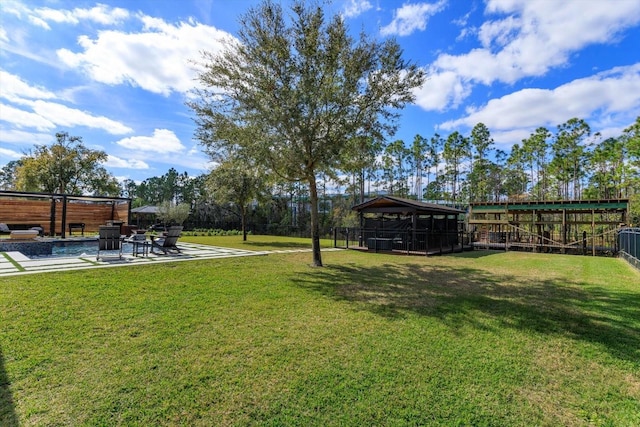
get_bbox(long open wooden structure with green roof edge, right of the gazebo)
[468,199,629,256]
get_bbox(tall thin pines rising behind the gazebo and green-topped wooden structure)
[346,117,640,205]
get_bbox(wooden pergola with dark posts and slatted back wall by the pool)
[0,191,131,238]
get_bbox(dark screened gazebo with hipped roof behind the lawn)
[350,196,465,254]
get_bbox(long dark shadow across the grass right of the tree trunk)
[298,264,640,364]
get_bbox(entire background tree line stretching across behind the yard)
[0,117,640,231]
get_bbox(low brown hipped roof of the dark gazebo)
[352,196,465,215]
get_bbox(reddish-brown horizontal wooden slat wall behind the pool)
[0,199,129,235]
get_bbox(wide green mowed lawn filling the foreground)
[0,236,640,426]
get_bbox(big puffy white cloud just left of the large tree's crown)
[57,16,231,95]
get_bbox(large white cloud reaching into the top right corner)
[419,0,640,110]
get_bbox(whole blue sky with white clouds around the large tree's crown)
[0,0,640,181]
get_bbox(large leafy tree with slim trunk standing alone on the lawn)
[188,1,424,266]
